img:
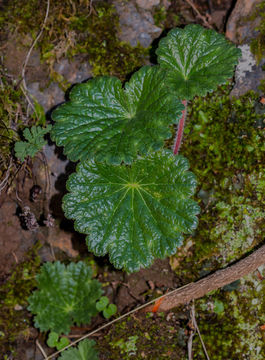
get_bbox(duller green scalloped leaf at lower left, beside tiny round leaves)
[28,261,102,335]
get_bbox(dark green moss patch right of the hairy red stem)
[181,85,265,190]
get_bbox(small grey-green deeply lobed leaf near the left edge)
[15,125,52,161]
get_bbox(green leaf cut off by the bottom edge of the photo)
[59,339,98,360]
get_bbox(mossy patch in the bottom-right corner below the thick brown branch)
[193,270,265,360]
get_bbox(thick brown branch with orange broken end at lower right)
[144,245,265,312]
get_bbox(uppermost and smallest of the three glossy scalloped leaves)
[156,25,241,100]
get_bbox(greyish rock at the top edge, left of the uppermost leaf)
[114,0,162,47]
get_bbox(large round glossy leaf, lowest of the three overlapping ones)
[63,150,199,272]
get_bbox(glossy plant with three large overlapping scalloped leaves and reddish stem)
[51,25,241,272]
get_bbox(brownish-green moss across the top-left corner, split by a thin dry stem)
[0,0,147,81]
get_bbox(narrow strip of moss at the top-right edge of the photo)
[250,1,265,62]
